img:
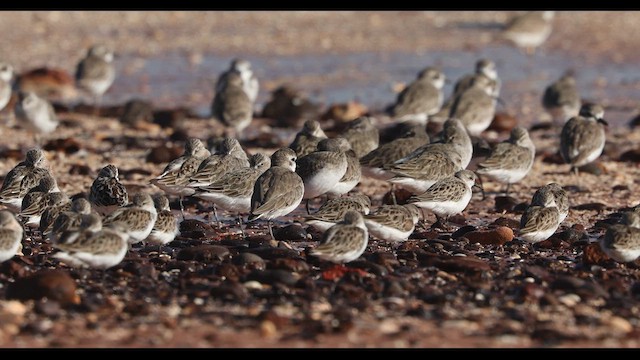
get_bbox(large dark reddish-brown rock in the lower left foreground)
[7,269,80,306]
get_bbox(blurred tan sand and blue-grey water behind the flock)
[0,11,640,125]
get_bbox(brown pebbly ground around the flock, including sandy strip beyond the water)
[0,12,640,348]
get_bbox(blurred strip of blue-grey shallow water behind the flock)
[104,46,640,126]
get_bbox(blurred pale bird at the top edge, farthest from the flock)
[502,11,555,55]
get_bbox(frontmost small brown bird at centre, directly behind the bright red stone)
[309,210,369,263]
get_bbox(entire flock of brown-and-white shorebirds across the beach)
[0,12,640,269]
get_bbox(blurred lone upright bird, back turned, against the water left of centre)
[211,72,253,138]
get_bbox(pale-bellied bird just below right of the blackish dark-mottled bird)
[103,193,158,244]
